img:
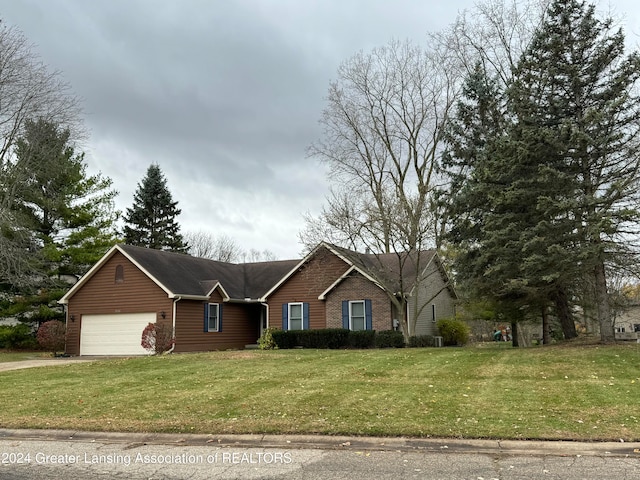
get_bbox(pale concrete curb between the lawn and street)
[0,429,640,459]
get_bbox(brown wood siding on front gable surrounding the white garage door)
[65,252,173,355]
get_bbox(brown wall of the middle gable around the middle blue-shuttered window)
[268,248,349,329]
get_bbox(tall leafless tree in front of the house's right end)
[300,41,460,338]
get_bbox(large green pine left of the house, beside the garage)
[9,119,118,277]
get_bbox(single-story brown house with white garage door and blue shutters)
[60,243,455,355]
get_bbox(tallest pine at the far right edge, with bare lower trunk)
[510,0,640,341]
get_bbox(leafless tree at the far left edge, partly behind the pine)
[0,23,83,284]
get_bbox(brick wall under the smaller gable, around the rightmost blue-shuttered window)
[326,272,393,331]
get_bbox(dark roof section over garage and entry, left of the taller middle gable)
[60,244,298,303]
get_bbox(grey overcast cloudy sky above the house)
[0,0,640,259]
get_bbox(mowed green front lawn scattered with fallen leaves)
[0,344,640,441]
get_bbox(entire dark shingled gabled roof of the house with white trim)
[60,243,455,304]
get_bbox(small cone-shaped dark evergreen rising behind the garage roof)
[124,164,188,253]
